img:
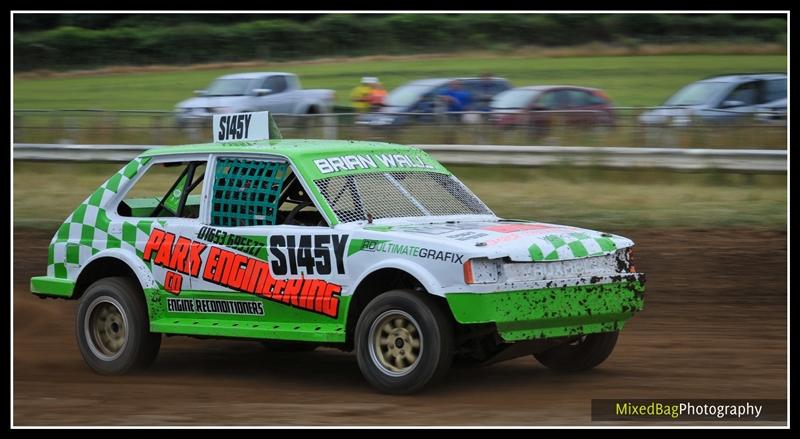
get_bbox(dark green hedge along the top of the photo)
[14,14,787,71]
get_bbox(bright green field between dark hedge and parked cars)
[14,52,787,110]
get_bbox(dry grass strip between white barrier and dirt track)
[13,161,787,231]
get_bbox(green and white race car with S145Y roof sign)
[30,112,644,394]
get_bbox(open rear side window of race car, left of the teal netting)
[117,161,206,218]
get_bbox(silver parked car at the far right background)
[639,73,786,125]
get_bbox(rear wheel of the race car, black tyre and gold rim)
[75,277,161,375]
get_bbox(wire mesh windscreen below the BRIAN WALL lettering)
[315,172,492,223]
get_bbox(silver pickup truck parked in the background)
[175,72,336,122]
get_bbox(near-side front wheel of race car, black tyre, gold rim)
[355,290,453,394]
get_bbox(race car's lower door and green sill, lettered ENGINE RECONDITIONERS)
[141,225,351,342]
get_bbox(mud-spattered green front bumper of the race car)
[445,273,644,342]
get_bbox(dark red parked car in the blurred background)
[491,85,614,128]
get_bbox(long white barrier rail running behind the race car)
[14,143,787,172]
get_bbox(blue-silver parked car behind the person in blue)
[357,76,511,126]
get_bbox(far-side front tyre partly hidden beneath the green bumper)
[533,332,619,372]
